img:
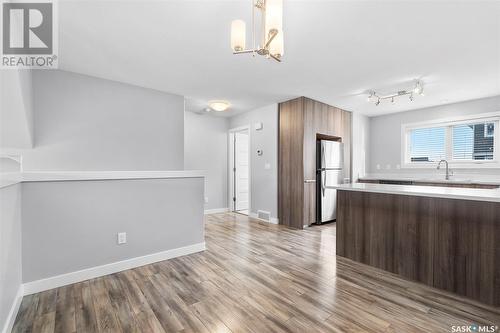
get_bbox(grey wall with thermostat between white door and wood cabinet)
[229,104,278,218]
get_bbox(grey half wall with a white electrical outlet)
[21,177,204,283]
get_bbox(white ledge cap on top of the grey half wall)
[0,170,205,188]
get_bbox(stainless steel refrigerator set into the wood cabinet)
[316,140,344,223]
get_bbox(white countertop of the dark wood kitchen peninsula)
[329,183,500,202]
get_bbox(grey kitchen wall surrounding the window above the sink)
[369,96,500,175]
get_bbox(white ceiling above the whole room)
[59,0,500,116]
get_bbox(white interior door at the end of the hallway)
[234,130,249,211]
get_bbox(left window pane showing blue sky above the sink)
[409,127,446,162]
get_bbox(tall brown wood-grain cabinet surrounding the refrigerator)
[278,97,351,229]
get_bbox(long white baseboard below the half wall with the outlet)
[24,242,206,295]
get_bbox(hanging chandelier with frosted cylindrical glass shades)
[231,0,284,62]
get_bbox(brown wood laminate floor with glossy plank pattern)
[13,213,500,333]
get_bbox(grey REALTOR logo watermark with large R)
[1,0,58,69]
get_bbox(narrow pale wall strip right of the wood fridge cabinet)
[352,112,370,182]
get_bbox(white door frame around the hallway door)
[227,125,252,216]
